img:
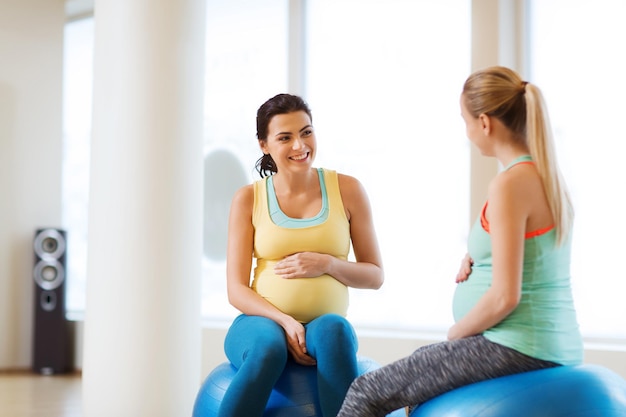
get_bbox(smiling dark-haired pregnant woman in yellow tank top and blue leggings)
[218,94,383,417]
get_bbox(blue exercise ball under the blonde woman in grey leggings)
[411,365,626,417]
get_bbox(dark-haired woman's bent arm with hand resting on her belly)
[274,174,384,289]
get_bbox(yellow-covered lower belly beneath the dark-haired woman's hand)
[252,268,348,323]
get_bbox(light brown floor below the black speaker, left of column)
[0,372,82,417]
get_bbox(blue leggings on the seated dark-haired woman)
[218,314,358,417]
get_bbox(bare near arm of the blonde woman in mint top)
[448,175,529,340]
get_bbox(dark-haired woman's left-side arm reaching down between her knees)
[226,185,315,365]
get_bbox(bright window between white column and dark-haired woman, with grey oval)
[202,0,289,321]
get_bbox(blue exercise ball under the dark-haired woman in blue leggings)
[193,357,406,417]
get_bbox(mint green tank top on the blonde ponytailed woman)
[453,156,583,365]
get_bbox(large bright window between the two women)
[306,0,471,331]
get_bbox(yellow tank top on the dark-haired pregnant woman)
[252,169,350,323]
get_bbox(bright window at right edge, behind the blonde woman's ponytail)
[529,0,626,339]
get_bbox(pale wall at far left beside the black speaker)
[0,0,65,369]
